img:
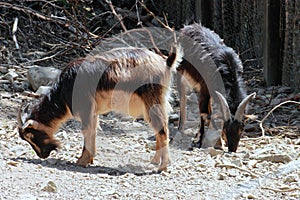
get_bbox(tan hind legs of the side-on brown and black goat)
[145,105,170,171]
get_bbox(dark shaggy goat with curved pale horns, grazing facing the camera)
[177,23,255,152]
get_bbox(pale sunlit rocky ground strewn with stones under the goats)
[0,65,300,199]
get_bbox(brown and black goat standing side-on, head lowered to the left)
[18,47,181,171]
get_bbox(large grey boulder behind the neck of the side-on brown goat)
[27,66,61,91]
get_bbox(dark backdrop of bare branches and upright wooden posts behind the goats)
[0,0,300,92]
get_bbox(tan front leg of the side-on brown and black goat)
[77,108,98,167]
